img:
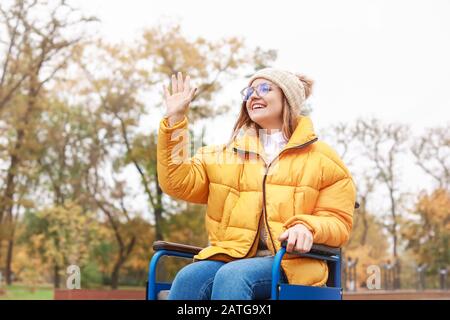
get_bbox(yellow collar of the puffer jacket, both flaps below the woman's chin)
[231,116,317,155]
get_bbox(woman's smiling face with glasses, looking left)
[246,78,283,129]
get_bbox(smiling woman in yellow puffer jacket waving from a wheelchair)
[157,68,355,300]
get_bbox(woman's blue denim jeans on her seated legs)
[168,256,285,300]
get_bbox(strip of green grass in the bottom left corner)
[0,284,53,300]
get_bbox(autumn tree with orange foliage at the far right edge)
[402,125,450,272]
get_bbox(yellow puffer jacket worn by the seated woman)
[157,116,356,286]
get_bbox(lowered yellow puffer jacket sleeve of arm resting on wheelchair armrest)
[283,154,356,247]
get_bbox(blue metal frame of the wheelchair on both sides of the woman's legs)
[146,242,342,300]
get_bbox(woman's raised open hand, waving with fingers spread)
[164,72,197,126]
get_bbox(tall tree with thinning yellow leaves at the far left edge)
[0,0,92,283]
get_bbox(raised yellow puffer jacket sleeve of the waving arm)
[157,117,209,204]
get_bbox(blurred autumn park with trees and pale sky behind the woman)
[0,0,450,299]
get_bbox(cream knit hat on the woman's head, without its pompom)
[249,68,306,112]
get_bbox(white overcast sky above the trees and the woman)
[72,0,450,219]
